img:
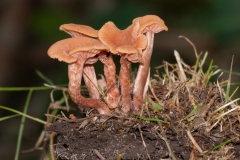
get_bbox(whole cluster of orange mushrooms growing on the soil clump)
[48,15,168,115]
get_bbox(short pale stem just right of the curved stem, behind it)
[83,64,100,99]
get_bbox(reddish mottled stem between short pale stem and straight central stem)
[99,53,120,108]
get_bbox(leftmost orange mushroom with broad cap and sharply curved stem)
[48,37,111,115]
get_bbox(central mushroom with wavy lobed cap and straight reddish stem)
[98,21,147,113]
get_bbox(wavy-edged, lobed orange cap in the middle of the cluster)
[98,21,147,61]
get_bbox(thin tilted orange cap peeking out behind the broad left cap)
[59,23,98,38]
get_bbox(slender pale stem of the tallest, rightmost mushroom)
[133,32,154,112]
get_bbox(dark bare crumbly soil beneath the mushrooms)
[48,118,192,160]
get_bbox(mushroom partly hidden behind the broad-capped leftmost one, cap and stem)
[60,23,100,99]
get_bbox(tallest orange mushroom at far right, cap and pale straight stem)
[133,15,168,112]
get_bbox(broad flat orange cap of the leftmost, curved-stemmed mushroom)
[48,37,108,63]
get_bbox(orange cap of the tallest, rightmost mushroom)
[133,15,168,34]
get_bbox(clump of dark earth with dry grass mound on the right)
[47,52,240,160]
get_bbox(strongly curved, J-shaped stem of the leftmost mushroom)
[68,60,111,115]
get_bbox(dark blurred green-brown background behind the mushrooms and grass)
[0,0,240,160]
